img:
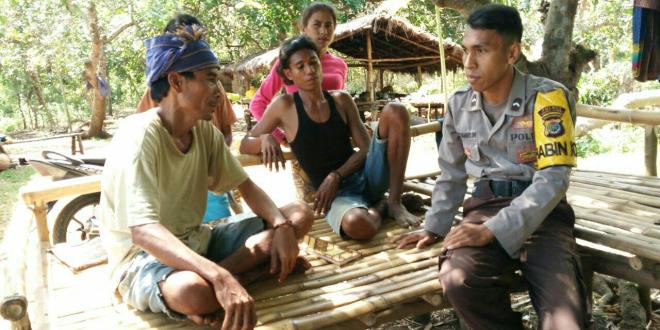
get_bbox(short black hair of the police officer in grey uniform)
[467,4,523,42]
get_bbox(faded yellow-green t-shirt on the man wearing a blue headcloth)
[100,109,247,288]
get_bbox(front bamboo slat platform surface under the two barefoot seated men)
[30,209,442,329]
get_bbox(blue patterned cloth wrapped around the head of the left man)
[144,24,219,87]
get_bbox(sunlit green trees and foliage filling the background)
[0,0,648,137]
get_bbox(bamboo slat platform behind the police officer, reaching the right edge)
[404,170,660,288]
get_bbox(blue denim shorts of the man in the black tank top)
[326,124,390,235]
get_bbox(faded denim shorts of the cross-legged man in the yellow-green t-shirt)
[117,213,265,320]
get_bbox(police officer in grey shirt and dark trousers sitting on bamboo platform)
[396,5,589,329]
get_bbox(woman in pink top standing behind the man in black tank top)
[250,2,348,142]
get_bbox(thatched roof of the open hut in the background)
[222,14,463,76]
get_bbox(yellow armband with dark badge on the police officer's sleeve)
[534,88,577,169]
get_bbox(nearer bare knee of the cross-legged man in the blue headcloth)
[159,271,219,315]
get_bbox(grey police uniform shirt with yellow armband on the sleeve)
[424,68,577,258]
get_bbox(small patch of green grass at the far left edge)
[0,166,35,227]
